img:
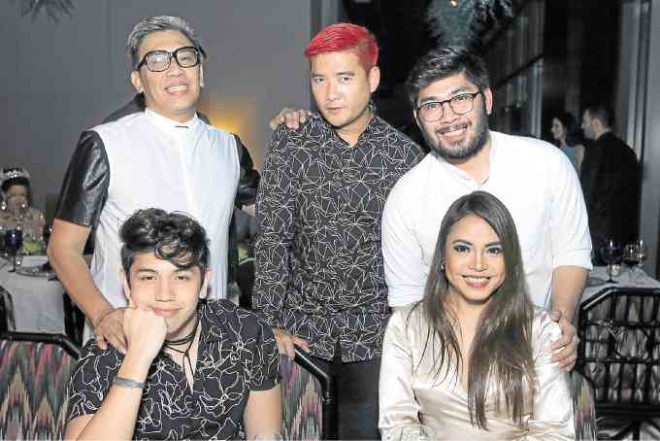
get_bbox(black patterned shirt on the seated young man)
[67,300,279,439]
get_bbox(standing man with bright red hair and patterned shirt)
[254,23,423,439]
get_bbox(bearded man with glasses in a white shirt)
[383,48,591,369]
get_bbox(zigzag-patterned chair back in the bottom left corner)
[0,333,79,440]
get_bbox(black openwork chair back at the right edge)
[578,287,660,439]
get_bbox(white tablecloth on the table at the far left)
[0,256,64,333]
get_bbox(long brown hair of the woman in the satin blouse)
[417,191,535,429]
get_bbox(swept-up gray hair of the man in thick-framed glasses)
[126,15,206,69]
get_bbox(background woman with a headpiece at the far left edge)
[0,167,46,243]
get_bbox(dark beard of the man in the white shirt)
[422,109,489,162]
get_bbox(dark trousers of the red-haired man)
[312,357,380,440]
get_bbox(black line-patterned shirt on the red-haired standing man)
[253,115,423,362]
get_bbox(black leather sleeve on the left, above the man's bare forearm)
[55,131,110,227]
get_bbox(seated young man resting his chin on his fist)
[65,209,282,439]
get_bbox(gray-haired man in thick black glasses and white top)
[48,16,240,352]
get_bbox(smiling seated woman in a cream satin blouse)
[379,192,574,440]
